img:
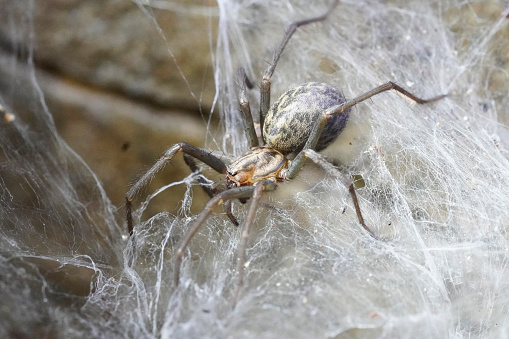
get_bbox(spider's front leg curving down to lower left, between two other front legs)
[173,181,275,286]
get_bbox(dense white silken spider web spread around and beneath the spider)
[0,0,509,338]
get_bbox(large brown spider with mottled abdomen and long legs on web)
[126,0,446,306]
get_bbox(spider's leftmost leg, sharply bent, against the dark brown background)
[125,142,226,235]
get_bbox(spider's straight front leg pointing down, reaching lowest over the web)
[232,180,276,307]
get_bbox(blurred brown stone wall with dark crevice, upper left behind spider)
[0,0,219,223]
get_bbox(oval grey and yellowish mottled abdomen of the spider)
[263,82,349,154]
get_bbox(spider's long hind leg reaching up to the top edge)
[260,0,339,131]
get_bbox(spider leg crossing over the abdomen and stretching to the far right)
[300,81,447,152]
